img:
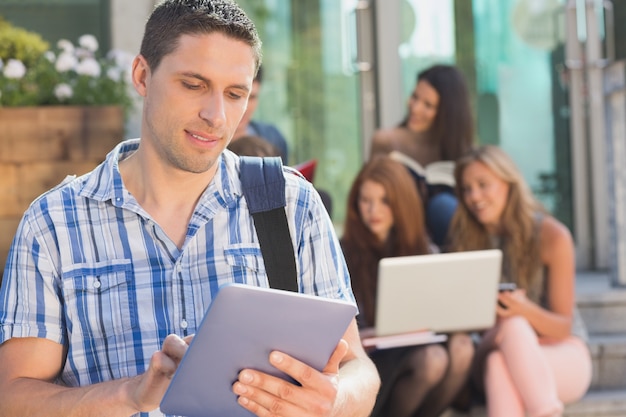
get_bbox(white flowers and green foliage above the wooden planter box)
[0,18,132,109]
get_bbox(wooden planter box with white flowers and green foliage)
[0,18,134,264]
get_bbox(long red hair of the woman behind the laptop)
[341,155,429,325]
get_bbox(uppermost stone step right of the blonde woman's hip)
[576,271,626,335]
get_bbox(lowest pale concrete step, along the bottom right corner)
[441,389,626,417]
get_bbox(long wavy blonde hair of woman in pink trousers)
[449,145,545,289]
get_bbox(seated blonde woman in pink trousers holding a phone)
[450,146,591,417]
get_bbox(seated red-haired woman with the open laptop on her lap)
[341,156,474,417]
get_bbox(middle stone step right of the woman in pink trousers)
[589,334,626,390]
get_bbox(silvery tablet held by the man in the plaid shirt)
[161,284,357,417]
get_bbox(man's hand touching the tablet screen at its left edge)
[129,334,193,412]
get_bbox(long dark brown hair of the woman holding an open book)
[400,65,474,161]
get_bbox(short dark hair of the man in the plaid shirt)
[140,0,262,71]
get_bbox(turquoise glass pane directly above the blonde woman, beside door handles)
[473,0,570,219]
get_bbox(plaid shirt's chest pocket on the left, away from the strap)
[63,259,138,338]
